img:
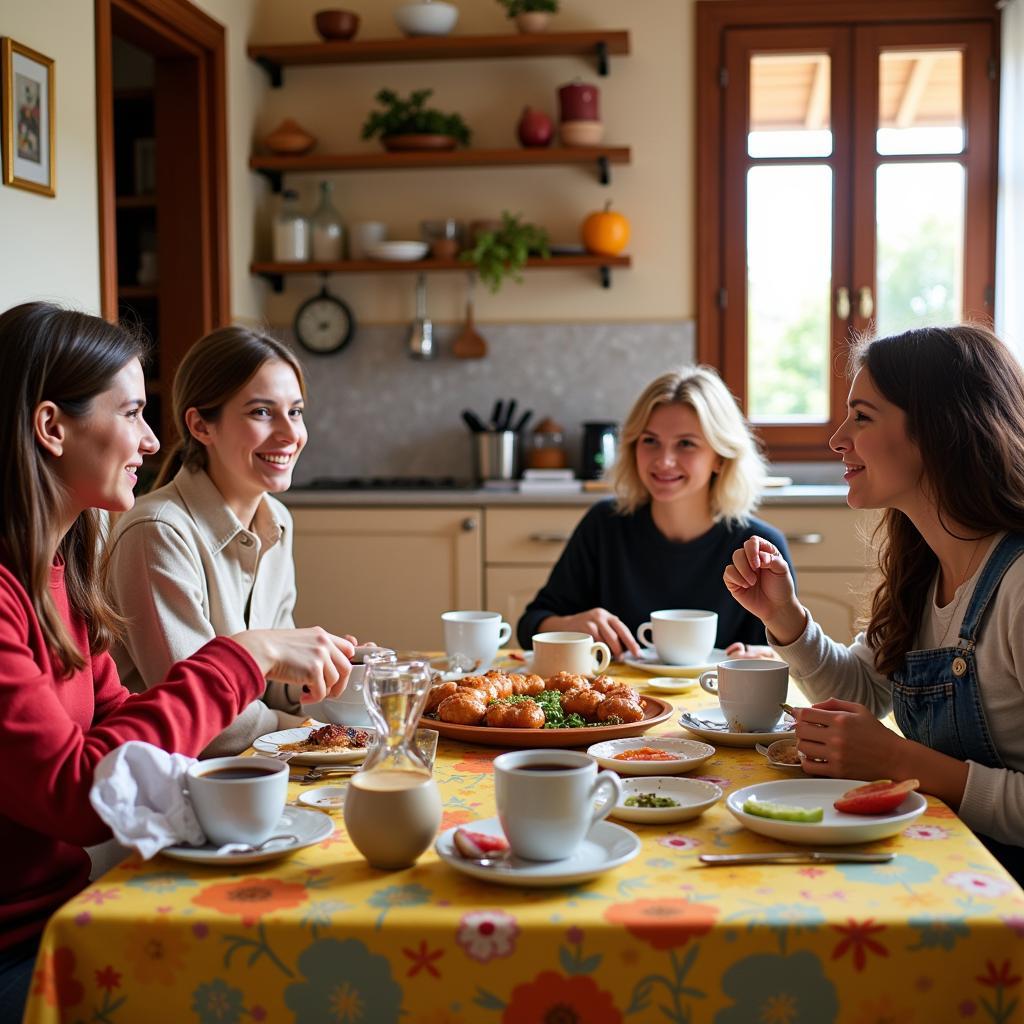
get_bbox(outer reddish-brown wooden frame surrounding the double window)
[694,0,999,461]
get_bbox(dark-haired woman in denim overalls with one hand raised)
[725,326,1024,881]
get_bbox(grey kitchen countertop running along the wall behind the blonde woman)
[276,483,848,508]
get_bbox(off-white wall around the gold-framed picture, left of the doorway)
[0,0,99,312]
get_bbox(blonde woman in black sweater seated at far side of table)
[517,367,788,654]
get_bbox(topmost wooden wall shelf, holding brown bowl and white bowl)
[249,30,630,88]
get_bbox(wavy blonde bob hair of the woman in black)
[609,366,766,525]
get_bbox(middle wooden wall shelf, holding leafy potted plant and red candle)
[249,145,632,191]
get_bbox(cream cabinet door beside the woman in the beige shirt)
[291,507,483,650]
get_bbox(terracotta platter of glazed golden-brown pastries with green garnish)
[421,671,672,748]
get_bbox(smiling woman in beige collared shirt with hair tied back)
[106,327,329,757]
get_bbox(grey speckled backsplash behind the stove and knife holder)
[285,322,694,483]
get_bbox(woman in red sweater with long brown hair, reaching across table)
[0,302,352,1021]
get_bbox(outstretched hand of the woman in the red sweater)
[231,626,355,703]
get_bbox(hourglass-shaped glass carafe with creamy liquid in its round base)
[345,660,441,870]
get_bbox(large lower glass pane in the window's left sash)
[746,165,833,423]
